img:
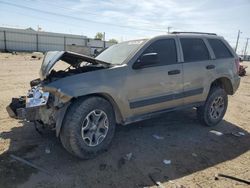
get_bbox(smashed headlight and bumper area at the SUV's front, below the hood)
[6,86,69,128]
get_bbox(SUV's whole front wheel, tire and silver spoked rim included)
[60,97,115,159]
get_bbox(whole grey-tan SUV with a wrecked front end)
[7,33,240,159]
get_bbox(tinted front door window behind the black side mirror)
[143,39,177,66]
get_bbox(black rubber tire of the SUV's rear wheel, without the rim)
[197,87,228,127]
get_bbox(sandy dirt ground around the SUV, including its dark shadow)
[0,53,250,188]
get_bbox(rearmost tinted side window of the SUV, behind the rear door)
[208,39,233,59]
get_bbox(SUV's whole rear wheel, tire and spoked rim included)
[197,87,228,127]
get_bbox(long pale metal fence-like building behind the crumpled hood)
[0,27,113,55]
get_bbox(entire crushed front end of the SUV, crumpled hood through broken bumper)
[6,51,109,136]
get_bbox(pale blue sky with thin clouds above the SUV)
[0,0,250,53]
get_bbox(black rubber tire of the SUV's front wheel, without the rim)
[60,97,116,159]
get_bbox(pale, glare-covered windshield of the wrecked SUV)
[96,39,146,64]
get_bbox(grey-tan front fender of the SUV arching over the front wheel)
[43,68,130,135]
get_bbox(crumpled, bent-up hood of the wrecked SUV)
[39,51,110,80]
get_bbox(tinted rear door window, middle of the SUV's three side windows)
[180,38,210,62]
